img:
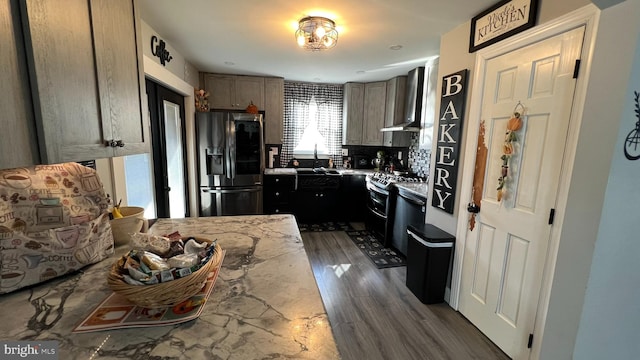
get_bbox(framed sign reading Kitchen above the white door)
[469,0,539,53]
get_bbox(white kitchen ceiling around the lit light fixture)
[139,0,498,83]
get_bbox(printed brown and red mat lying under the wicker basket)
[72,250,226,333]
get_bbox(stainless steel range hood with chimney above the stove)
[380,66,424,132]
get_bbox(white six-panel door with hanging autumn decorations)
[460,27,584,359]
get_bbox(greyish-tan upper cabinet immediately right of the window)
[342,83,364,145]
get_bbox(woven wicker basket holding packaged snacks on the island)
[107,237,222,308]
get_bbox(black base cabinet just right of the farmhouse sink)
[340,174,367,221]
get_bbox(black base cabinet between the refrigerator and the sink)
[264,175,296,214]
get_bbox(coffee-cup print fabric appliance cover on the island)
[0,163,114,293]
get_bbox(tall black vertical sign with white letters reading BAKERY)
[431,69,468,214]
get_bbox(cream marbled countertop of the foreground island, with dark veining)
[0,215,340,360]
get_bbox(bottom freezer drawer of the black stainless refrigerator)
[200,186,262,216]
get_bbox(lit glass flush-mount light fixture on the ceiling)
[296,16,338,51]
